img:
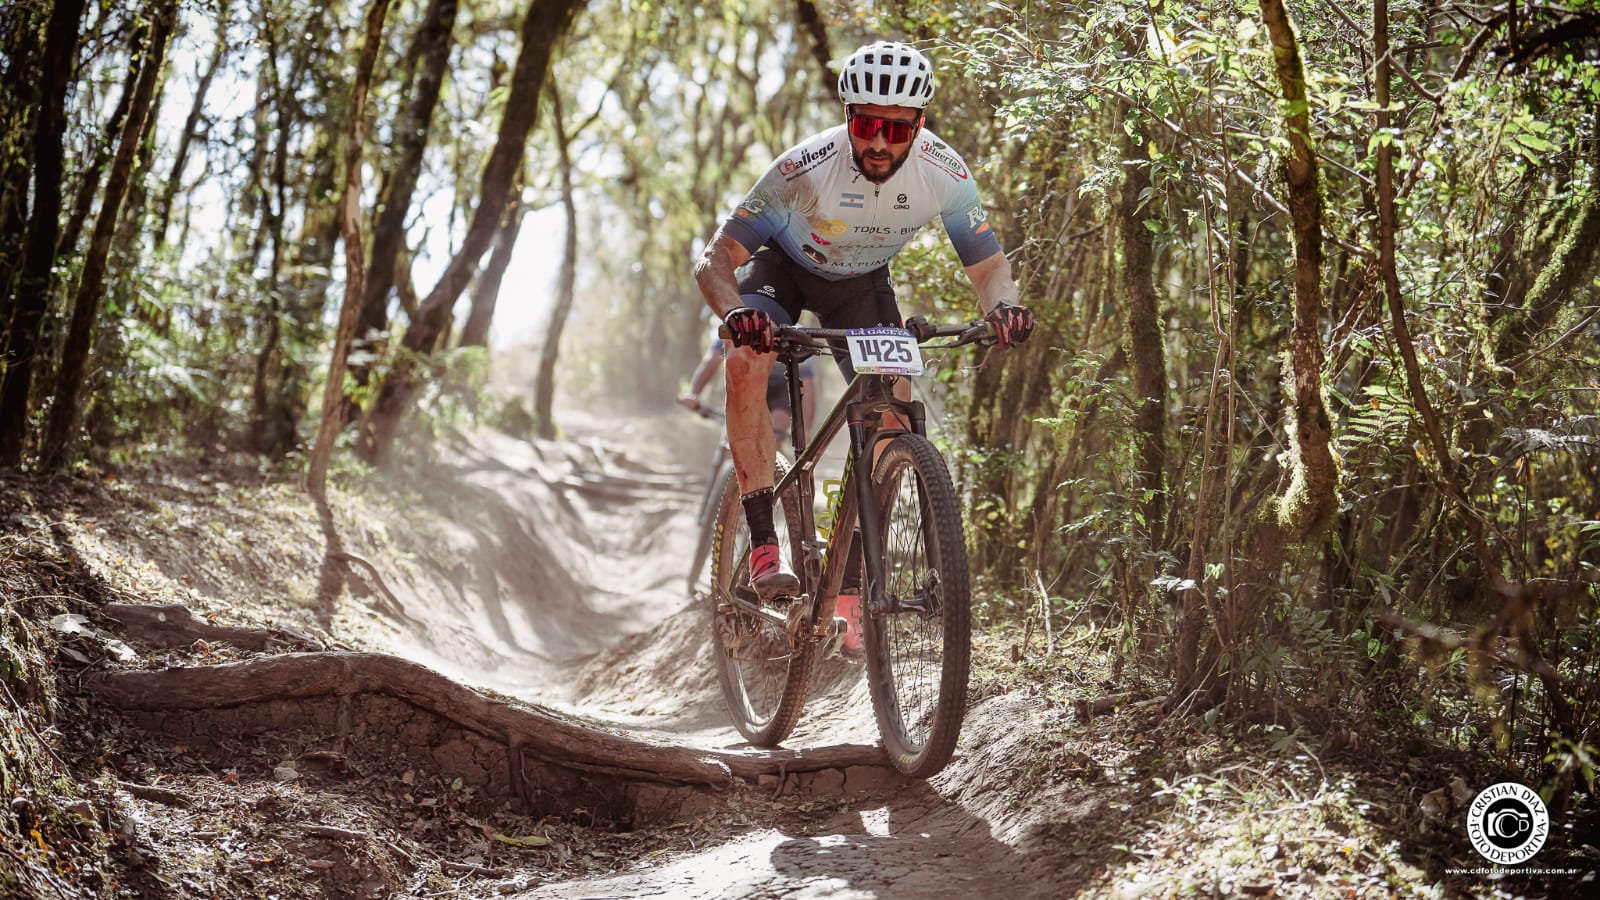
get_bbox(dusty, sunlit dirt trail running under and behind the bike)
[353,416,1075,900]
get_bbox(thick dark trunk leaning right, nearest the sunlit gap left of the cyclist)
[357,0,579,464]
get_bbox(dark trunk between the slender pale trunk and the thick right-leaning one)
[341,0,459,424]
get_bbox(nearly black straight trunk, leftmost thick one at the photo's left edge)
[0,0,88,466]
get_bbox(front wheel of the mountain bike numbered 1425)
[862,434,971,778]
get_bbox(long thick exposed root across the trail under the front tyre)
[83,652,888,786]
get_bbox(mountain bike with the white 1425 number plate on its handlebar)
[709,317,995,778]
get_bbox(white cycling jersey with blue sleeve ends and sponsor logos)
[723,125,1000,280]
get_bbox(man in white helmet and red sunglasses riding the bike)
[694,42,1034,652]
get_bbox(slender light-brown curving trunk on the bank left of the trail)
[306,0,389,501]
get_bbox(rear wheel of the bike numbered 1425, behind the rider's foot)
[707,460,816,746]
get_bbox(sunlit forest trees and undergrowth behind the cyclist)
[0,0,1600,798]
